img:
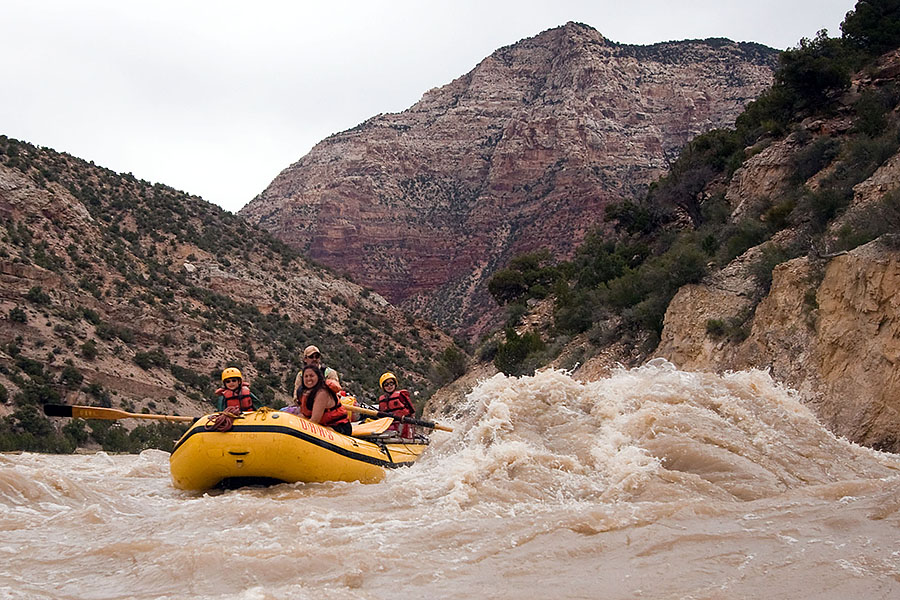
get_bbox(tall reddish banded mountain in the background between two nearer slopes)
[240,23,776,335]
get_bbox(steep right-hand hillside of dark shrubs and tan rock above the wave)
[464,7,900,452]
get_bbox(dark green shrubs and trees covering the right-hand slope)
[483,0,900,373]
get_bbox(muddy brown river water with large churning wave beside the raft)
[0,361,900,600]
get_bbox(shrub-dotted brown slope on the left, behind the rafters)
[0,136,461,450]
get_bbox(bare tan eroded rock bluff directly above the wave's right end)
[657,236,900,452]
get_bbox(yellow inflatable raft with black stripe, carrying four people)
[169,409,428,490]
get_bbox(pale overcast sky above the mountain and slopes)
[0,0,855,211]
